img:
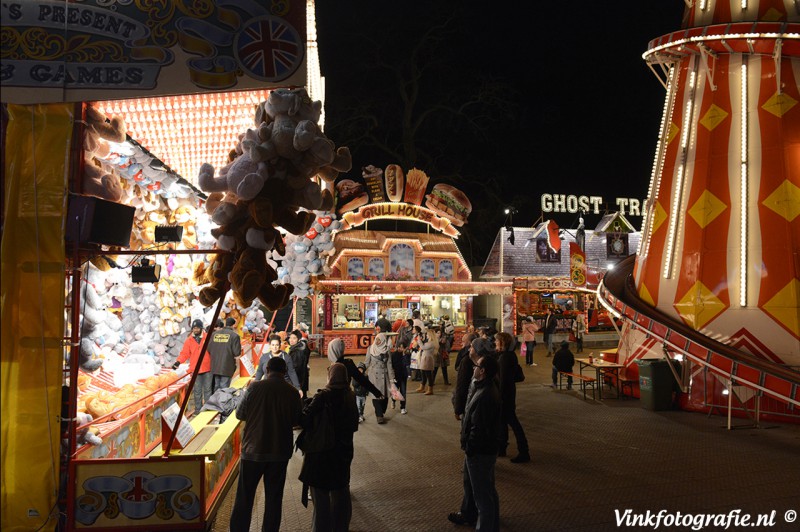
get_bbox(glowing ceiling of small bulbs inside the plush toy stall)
[94,89,269,185]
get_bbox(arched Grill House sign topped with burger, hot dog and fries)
[336,164,472,237]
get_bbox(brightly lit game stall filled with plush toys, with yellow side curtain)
[1,0,328,530]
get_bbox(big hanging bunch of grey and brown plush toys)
[195,89,352,310]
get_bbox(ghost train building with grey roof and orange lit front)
[481,208,640,345]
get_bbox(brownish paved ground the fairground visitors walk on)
[213,347,800,532]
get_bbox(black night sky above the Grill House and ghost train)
[317,0,684,260]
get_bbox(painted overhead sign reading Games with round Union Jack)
[0,0,306,104]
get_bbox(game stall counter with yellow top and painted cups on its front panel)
[70,377,250,530]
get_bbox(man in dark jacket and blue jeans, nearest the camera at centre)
[447,356,501,532]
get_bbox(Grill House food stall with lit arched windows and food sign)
[315,165,511,354]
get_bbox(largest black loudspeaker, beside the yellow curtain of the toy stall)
[66,194,136,248]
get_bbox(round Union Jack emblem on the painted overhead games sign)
[236,17,305,81]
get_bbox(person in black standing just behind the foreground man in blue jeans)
[495,332,531,464]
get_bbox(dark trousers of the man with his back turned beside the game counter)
[231,459,289,532]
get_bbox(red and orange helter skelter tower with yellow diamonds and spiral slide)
[598,0,800,427]
